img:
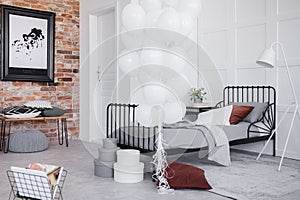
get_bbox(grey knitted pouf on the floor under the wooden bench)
[9,130,48,153]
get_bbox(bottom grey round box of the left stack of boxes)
[94,160,114,178]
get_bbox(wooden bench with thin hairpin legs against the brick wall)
[0,115,70,153]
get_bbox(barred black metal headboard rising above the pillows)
[223,86,276,106]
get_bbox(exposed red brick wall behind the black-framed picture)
[0,0,80,139]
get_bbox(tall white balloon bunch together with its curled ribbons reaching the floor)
[118,0,200,193]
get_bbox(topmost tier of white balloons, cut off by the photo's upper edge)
[121,0,201,36]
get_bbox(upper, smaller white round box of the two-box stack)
[117,149,140,166]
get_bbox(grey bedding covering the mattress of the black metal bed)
[113,122,255,150]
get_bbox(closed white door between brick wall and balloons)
[89,5,118,143]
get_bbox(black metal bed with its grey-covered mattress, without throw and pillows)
[106,86,276,156]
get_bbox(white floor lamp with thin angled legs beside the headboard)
[256,42,300,171]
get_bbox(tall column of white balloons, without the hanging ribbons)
[118,0,201,126]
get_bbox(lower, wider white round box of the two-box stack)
[114,163,144,183]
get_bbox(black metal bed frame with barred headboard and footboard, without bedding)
[106,86,276,156]
